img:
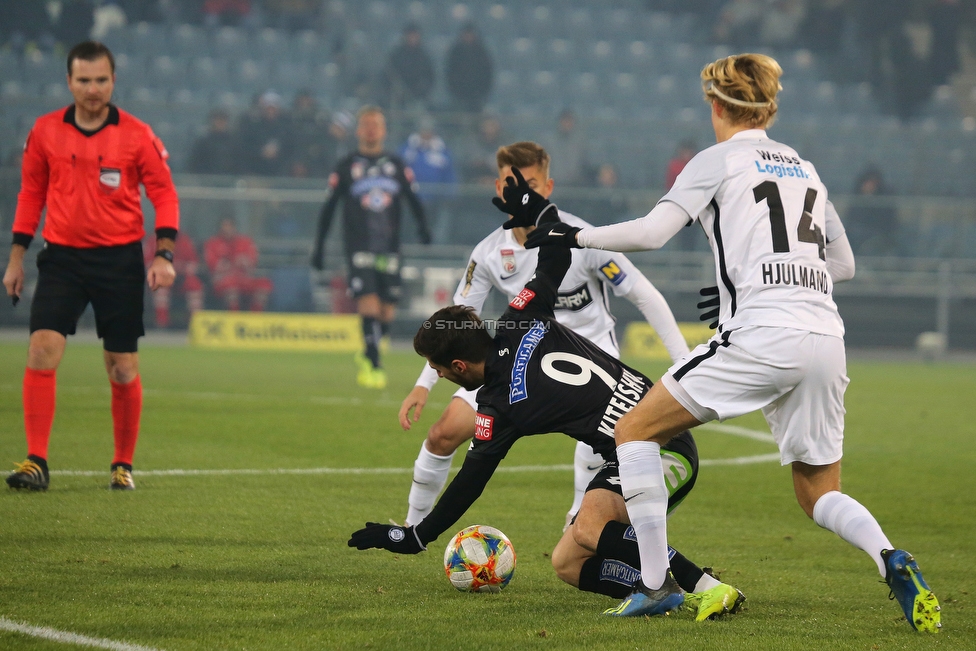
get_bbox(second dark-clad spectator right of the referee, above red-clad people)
[241,91,291,176]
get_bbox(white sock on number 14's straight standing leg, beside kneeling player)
[617,441,669,590]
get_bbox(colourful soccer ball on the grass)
[444,524,515,592]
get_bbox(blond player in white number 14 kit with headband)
[527,54,941,633]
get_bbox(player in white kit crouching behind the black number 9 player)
[399,142,688,526]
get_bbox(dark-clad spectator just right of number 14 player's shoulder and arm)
[844,166,898,255]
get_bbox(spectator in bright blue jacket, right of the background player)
[398,116,457,244]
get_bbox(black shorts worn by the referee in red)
[30,242,146,353]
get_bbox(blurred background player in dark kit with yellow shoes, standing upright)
[312,106,430,389]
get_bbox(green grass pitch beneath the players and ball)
[0,343,976,651]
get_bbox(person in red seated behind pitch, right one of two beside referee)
[203,217,272,312]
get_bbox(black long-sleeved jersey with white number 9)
[416,211,672,544]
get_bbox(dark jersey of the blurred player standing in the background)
[316,152,430,255]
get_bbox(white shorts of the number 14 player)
[661,326,850,466]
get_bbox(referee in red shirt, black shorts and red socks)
[3,41,179,490]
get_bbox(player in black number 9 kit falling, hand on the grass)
[349,168,744,620]
